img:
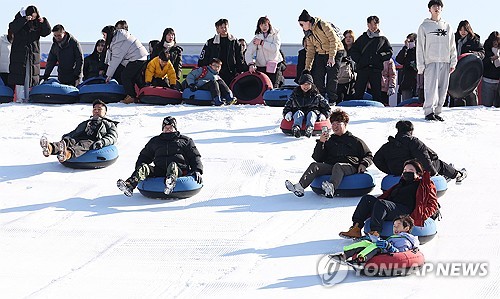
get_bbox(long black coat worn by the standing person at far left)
[9,12,51,87]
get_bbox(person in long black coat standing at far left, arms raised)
[9,6,50,101]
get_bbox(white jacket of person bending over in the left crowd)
[106,29,148,77]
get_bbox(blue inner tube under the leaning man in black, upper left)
[29,78,78,104]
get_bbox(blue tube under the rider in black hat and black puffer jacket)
[137,176,203,199]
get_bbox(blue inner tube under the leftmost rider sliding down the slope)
[62,145,118,169]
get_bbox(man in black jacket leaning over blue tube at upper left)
[42,24,83,86]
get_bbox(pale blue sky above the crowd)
[0,0,500,44]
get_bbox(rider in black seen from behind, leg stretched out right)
[373,120,467,183]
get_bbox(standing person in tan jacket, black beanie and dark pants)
[299,9,344,104]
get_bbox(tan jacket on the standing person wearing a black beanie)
[305,17,344,70]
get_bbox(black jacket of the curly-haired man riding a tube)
[312,131,373,169]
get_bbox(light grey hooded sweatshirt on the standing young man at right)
[416,19,457,74]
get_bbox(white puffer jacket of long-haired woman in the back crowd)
[245,28,284,67]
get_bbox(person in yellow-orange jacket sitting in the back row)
[144,51,177,87]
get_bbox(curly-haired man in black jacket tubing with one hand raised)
[285,109,373,197]
